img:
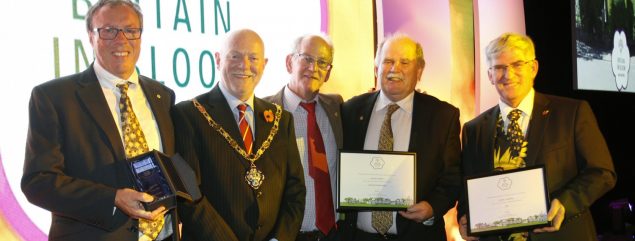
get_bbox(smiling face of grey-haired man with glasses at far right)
[487,49,538,107]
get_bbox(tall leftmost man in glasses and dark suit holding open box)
[22,0,178,240]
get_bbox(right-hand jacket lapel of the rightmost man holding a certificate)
[525,92,550,166]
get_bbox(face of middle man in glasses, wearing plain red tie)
[287,36,333,100]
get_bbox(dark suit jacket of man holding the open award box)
[22,66,177,240]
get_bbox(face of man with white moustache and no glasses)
[375,37,424,102]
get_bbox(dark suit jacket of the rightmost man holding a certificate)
[458,92,616,241]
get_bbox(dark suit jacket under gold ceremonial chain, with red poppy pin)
[173,86,306,241]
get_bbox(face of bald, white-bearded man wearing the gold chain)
[215,30,267,101]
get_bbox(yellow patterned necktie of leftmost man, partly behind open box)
[117,82,165,240]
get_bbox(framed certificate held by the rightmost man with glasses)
[465,166,551,236]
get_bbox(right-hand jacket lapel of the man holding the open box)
[139,76,174,154]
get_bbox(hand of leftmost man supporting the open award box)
[115,188,167,220]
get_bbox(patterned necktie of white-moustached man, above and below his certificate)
[371,103,399,235]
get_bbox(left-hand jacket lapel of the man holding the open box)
[76,65,126,160]
